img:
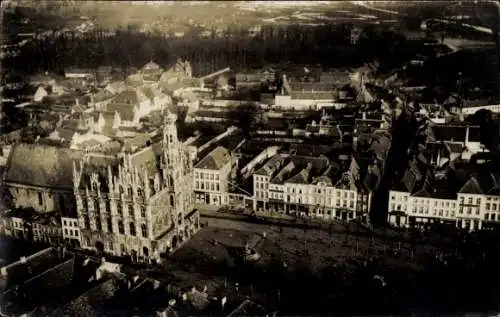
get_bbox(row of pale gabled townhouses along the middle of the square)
[253,154,371,221]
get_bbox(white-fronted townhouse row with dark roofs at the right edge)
[388,157,500,231]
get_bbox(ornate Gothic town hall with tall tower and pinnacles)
[74,113,200,261]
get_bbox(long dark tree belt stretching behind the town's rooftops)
[3,20,409,79]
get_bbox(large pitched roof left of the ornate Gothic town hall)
[5,144,83,190]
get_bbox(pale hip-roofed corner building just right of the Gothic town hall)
[194,146,235,206]
